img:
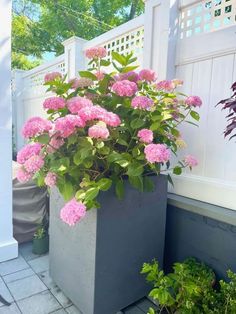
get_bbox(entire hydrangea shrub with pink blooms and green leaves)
[17,47,202,225]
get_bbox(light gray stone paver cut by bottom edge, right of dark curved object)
[17,290,61,314]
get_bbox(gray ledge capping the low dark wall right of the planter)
[168,193,236,226]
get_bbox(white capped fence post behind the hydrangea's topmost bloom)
[62,36,86,79]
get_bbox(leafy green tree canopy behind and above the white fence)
[12,0,144,69]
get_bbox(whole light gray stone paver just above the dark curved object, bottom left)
[7,275,47,300]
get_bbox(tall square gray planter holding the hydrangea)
[49,176,167,314]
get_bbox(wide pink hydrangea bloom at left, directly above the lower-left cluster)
[22,117,53,138]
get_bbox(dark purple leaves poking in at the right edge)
[218,82,236,139]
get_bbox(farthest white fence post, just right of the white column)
[12,70,26,151]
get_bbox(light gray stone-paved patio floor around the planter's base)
[0,243,157,314]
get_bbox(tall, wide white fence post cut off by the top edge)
[144,0,179,80]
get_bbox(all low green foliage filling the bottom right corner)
[141,258,236,314]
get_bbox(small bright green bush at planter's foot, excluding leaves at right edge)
[141,258,215,314]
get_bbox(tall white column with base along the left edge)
[0,0,18,262]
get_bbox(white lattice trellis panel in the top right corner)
[180,0,236,39]
